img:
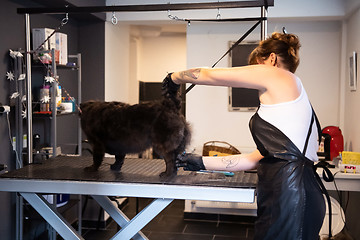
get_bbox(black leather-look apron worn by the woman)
[249,112,326,240]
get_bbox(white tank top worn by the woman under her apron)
[258,78,318,161]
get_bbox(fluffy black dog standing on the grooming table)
[80,75,190,177]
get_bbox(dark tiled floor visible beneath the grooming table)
[83,198,254,240]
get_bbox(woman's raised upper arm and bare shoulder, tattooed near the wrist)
[171,64,300,104]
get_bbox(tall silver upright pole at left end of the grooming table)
[25,14,33,164]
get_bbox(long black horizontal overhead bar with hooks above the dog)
[17,0,274,14]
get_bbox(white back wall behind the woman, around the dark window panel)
[186,21,341,152]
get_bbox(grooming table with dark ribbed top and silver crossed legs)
[0,156,257,240]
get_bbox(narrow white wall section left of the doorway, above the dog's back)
[105,22,130,102]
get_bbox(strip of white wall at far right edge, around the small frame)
[344,9,360,152]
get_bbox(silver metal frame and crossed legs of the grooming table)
[0,178,255,240]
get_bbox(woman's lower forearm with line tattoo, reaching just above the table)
[202,150,263,172]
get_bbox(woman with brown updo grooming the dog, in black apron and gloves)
[164,33,325,240]
